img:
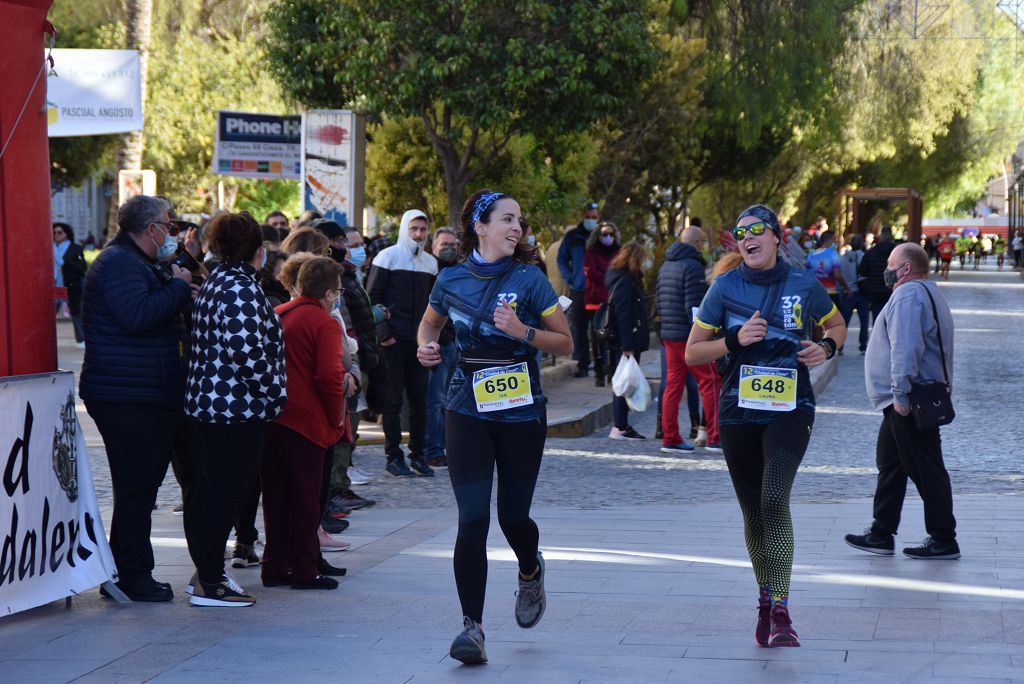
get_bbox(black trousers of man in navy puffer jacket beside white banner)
[85,401,187,581]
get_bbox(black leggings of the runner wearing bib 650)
[444,411,547,623]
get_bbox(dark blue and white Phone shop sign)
[213,110,302,180]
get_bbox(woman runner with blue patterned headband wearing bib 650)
[416,190,572,665]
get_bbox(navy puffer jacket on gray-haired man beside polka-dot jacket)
[79,231,191,409]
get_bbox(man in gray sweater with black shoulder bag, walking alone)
[846,244,961,559]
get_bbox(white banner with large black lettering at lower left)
[0,372,117,616]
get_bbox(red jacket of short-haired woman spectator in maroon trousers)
[274,297,345,448]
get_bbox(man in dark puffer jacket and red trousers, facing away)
[656,225,721,454]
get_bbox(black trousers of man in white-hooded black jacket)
[381,340,430,462]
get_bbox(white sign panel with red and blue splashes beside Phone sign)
[302,110,365,225]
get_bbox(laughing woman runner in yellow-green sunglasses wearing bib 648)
[686,205,846,646]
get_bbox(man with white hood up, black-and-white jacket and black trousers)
[367,209,437,477]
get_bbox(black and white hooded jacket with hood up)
[367,209,437,342]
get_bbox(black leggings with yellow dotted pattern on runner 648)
[719,410,814,596]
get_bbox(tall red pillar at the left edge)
[0,0,57,377]
